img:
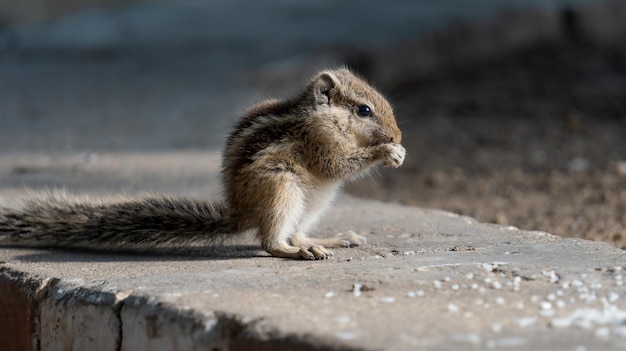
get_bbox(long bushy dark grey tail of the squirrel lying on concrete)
[0,193,234,251]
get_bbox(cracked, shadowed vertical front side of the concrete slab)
[0,266,350,351]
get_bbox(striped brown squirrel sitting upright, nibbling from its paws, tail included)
[0,68,406,259]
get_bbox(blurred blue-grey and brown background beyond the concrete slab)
[0,0,626,249]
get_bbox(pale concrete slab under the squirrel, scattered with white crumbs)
[0,152,626,350]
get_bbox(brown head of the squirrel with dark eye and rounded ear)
[307,69,402,146]
